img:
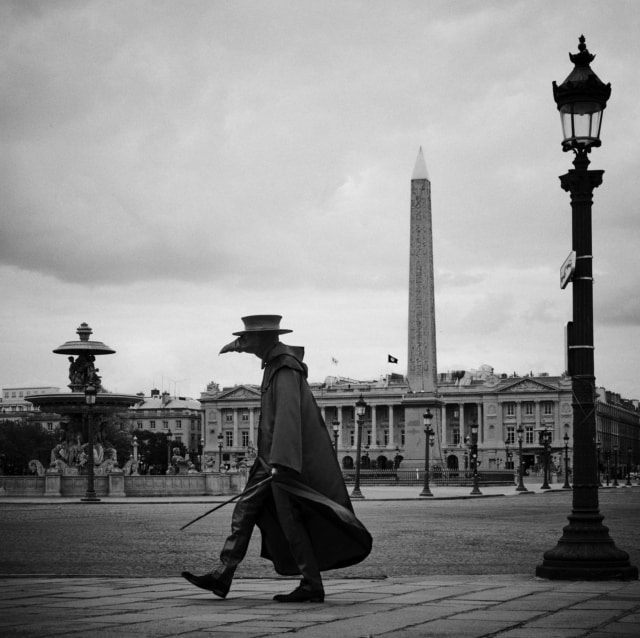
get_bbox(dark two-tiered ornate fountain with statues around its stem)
[29,323,140,502]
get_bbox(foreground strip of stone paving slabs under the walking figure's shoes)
[0,575,640,638]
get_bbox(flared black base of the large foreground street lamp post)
[536,511,638,580]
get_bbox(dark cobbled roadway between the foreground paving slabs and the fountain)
[0,486,640,578]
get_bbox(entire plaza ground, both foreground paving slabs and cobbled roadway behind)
[0,484,640,638]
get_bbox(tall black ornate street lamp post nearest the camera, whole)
[536,36,638,580]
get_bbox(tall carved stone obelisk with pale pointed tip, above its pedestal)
[407,147,437,393]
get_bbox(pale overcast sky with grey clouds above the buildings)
[0,0,640,398]
